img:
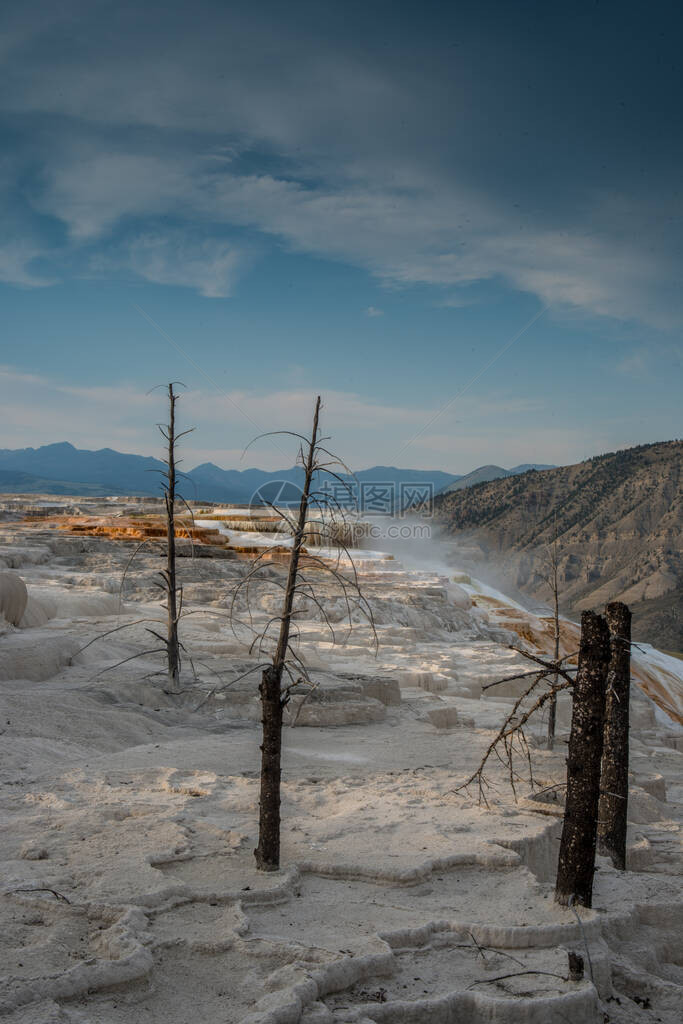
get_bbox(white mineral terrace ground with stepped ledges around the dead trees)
[0,508,683,1024]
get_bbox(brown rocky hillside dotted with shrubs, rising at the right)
[434,441,683,651]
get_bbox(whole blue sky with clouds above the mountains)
[0,0,683,473]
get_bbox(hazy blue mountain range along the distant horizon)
[0,441,548,511]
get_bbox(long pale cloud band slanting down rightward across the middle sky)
[24,146,683,328]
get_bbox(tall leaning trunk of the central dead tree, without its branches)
[254,395,321,871]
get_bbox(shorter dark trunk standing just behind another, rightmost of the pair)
[598,601,631,871]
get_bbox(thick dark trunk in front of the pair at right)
[555,611,609,906]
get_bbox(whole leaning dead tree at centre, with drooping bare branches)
[230,396,376,871]
